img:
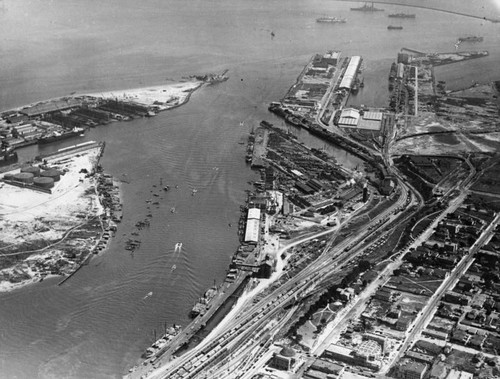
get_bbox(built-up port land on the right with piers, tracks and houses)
[130,49,500,379]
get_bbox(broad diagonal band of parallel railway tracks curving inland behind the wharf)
[151,166,414,378]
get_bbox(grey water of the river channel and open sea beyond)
[0,0,500,378]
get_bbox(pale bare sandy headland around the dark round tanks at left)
[0,144,106,292]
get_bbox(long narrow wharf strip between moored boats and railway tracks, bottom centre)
[125,271,250,379]
